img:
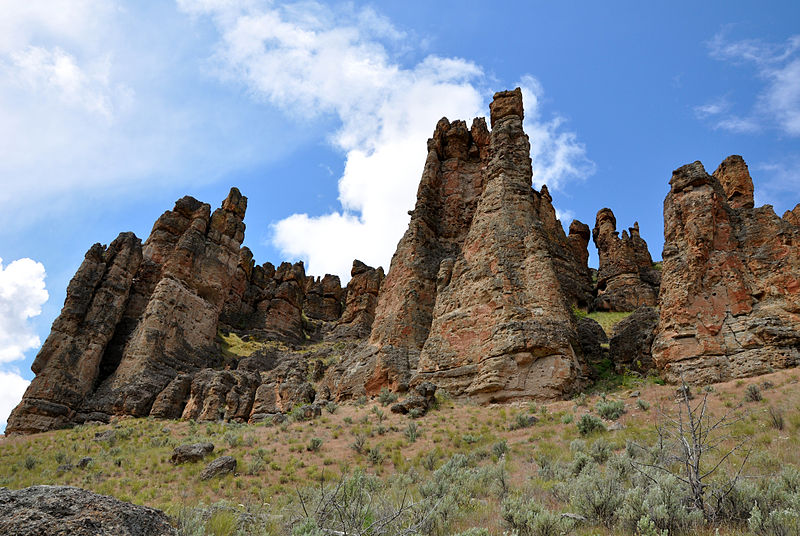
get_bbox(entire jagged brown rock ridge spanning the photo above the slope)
[7,89,800,433]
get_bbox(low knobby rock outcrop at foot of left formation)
[182,369,261,422]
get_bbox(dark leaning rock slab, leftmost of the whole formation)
[6,233,142,434]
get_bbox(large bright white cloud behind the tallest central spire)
[179,0,593,280]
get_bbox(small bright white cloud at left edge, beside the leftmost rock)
[0,259,49,363]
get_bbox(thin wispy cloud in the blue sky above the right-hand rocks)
[695,31,800,136]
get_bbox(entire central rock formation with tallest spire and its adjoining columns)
[334,89,591,401]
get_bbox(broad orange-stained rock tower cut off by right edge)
[652,156,800,383]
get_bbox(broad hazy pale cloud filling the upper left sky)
[0,0,301,228]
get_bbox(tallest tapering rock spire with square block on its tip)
[416,89,581,402]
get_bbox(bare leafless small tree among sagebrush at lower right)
[634,383,750,521]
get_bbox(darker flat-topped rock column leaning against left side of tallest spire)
[360,118,489,392]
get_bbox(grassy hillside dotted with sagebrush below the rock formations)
[0,371,800,535]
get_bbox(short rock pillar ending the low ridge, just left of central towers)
[329,260,384,339]
